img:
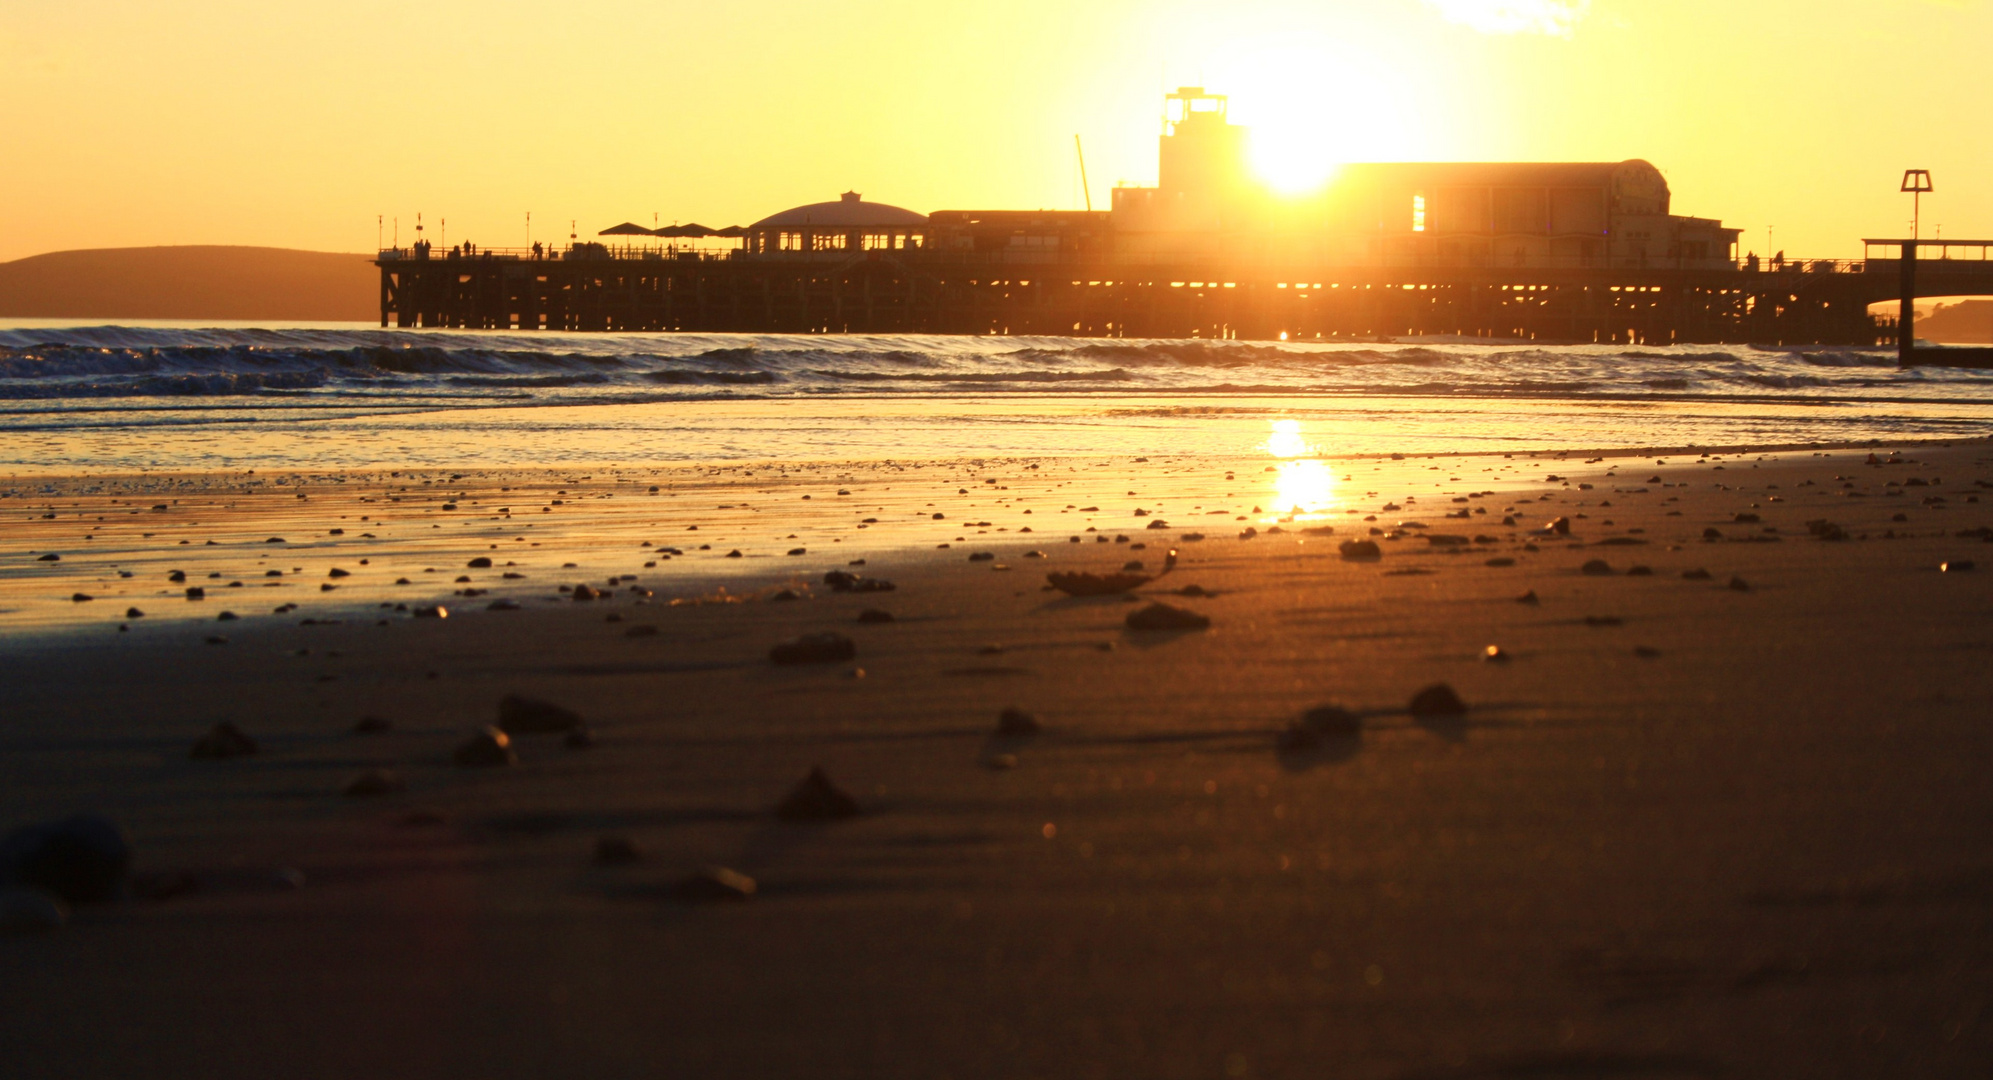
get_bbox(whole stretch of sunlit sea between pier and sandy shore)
[0,319,1993,476]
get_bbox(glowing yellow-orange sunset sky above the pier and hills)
[0,0,1993,259]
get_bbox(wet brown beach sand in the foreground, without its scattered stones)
[0,442,1993,1078]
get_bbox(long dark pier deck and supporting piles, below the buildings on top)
[377,241,1993,347]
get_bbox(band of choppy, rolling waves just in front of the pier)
[0,327,1993,408]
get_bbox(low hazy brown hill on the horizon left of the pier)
[0,245,381,323]
